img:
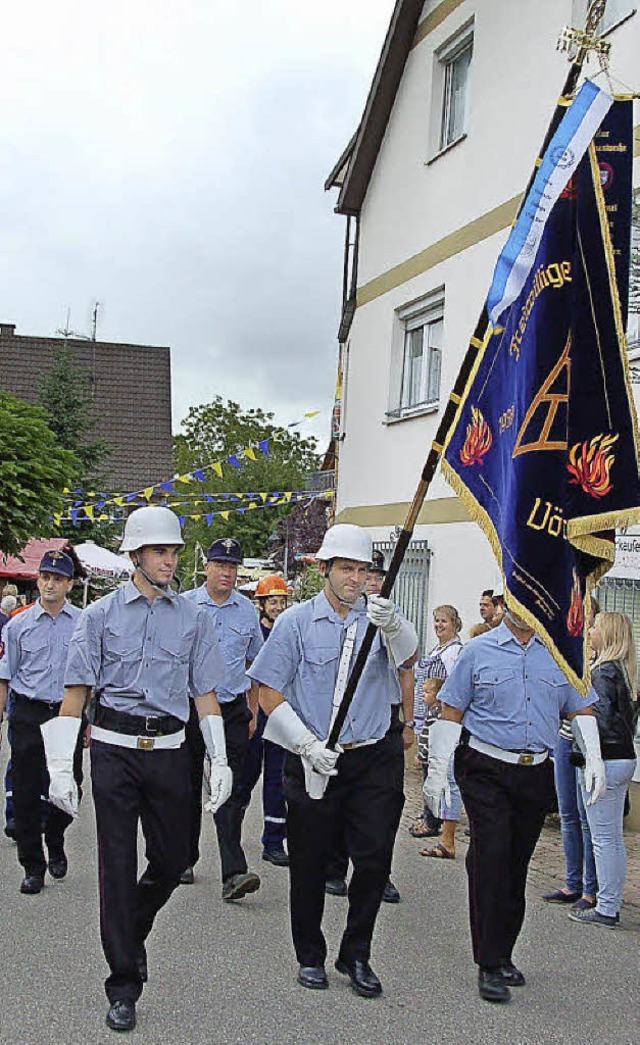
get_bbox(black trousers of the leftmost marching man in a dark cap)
[12,694,83,875]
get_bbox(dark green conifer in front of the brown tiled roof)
[38,342,116,543]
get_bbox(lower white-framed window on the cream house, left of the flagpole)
[387,291,444,420]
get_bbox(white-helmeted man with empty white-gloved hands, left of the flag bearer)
[43,505,231,1031]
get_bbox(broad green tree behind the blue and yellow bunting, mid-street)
[172,396,318,585]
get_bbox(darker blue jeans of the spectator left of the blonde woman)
[553,737,598,897]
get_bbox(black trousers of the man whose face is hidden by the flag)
[455,744,554,968]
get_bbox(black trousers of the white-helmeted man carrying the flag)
[284,732,405,966]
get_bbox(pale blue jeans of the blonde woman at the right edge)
[579,759,636,918]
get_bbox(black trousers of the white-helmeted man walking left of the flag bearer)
[91,740,191,1003]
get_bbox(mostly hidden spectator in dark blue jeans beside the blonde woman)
[543,598,600,910]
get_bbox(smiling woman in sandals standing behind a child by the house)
[409,605,462,860]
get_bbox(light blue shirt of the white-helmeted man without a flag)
[65,581,225,722]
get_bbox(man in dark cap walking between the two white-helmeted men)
[184,537,262,901]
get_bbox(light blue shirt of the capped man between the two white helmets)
[184,584,265,704]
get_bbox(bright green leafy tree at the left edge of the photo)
[0,392,79,555]
